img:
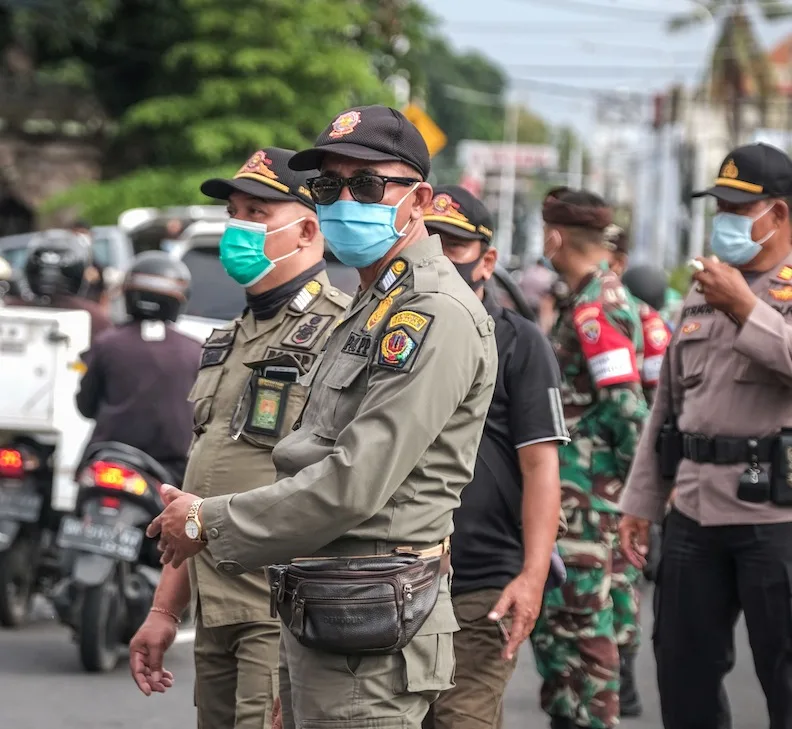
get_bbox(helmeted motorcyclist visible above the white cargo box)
[4,230,113,341]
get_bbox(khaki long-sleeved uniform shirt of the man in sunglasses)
[202,236,497,633]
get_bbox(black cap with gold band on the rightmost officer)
[693,143,792,205]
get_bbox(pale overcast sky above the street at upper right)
[424,0,792,131]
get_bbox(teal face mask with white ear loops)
[220,217,305,288]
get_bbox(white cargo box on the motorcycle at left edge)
[0,307,93,511]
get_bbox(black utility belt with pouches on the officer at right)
[679,428,792,507]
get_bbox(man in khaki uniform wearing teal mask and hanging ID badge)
[131,148,350,729]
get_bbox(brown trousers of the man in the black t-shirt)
[423,588,517,729]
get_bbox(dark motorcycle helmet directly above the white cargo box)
[25,230,92,296]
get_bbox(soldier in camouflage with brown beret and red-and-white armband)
[531,188,647,729]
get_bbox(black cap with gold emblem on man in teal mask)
[201,147,316,210]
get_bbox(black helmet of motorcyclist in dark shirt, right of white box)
[124,251,192,321]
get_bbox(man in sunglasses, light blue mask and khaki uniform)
[145,106,497,729]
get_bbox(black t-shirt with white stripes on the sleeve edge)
[451,292,568,595]
